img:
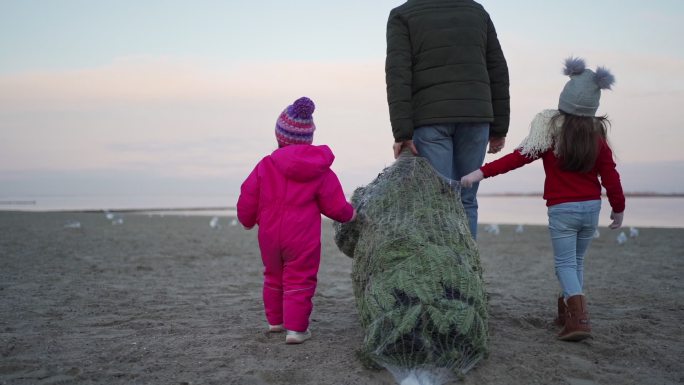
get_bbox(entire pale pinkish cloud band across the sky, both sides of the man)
[0,51,684,196]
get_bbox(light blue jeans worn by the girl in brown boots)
[548,200,601,299]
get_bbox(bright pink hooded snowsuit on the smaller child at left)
[237,144,354,332]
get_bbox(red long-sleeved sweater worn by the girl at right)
[480,139,625,213]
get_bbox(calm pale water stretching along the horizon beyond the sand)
[0,195,684,227]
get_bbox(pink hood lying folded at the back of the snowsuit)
[271,144,335,182]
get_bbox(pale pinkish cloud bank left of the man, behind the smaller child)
[0,57,391,184]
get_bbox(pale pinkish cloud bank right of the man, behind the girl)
[487,41,684,162]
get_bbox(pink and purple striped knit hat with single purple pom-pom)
[276,96,316,147]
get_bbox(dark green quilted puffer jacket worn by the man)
[385,0,510,142]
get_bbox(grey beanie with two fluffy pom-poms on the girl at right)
[558,57,615,116]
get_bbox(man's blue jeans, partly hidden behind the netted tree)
[413,123,489,239]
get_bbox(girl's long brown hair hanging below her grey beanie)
[552,111,610,172]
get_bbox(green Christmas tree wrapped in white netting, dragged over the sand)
[334,153,488,384]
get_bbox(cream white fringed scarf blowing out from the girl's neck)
[516,110,563,158]
